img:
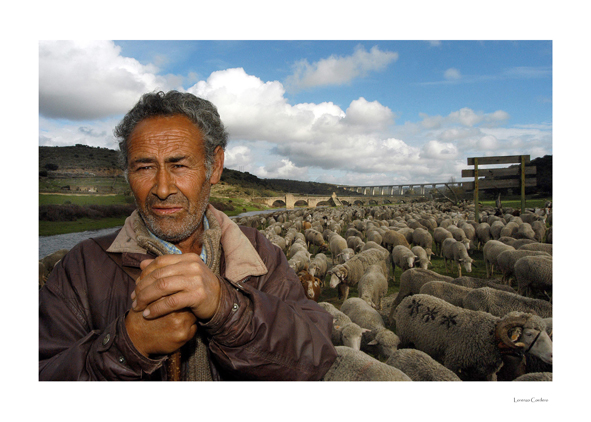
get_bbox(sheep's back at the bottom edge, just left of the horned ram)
[386,349,461,381]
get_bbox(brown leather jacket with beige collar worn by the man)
[39,206,336,380]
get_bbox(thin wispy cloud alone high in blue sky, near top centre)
[286,46,398,89]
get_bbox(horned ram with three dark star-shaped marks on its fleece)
[395,294,552,381]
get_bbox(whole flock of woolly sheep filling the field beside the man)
[236,202,552,381]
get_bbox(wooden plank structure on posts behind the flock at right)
[462,155,537,222]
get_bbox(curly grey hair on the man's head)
[113,91,228,178]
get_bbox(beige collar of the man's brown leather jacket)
[107,204,268,282]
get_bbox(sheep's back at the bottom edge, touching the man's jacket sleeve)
[322,346,412,381]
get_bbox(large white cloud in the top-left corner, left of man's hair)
[39,41,179,120]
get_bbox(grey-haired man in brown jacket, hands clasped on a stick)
[39,91,336,380]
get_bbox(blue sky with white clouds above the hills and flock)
[39,39,553,186]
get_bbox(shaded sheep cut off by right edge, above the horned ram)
[514,256,552,297]
